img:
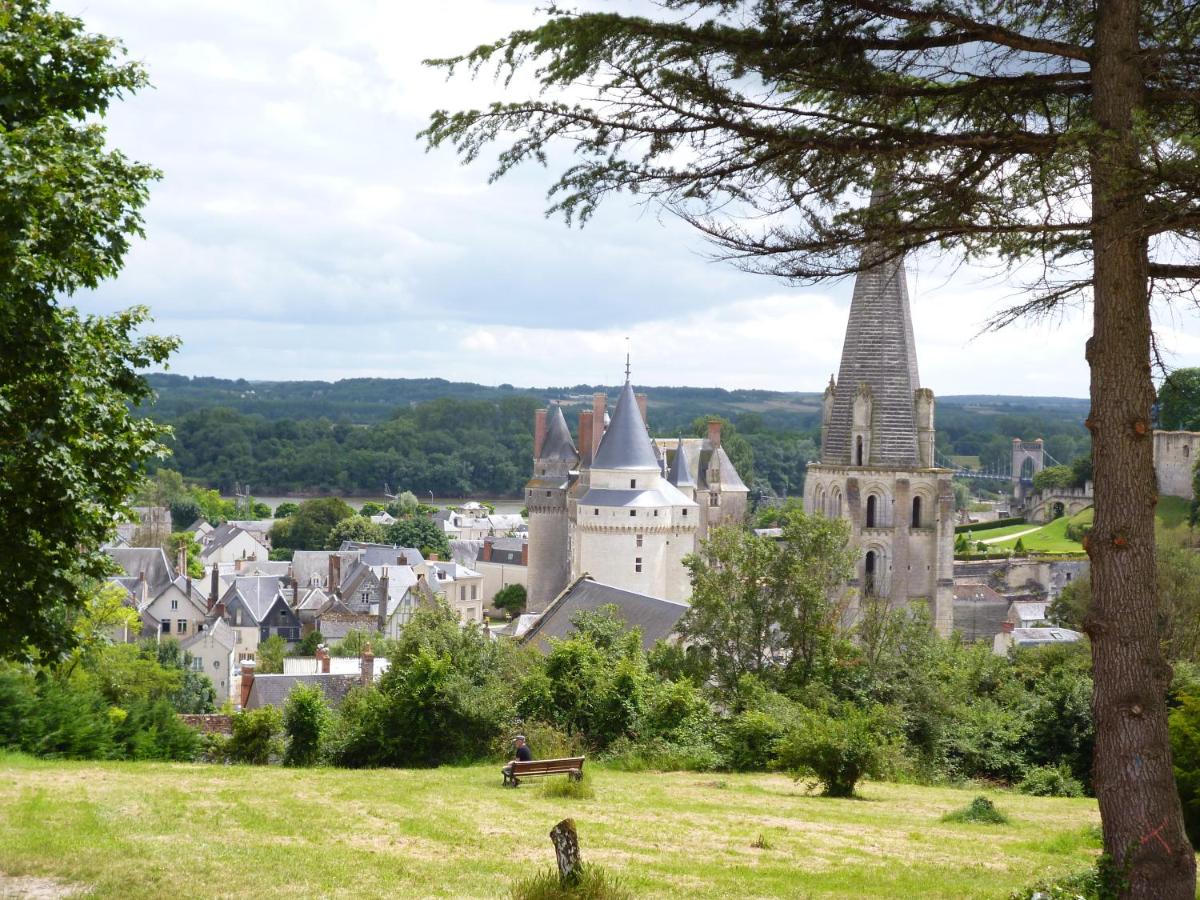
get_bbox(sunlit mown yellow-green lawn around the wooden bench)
[0,754,1099,899]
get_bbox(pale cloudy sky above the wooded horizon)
[55,0,1200,396]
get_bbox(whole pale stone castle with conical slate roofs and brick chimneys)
[526,374,749,613]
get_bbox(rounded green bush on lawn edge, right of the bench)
[775,703,896,797]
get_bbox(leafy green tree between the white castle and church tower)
[679,504,857,703]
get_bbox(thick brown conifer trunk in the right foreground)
[1086,0,1195,900]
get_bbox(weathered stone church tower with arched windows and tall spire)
[804,223,954,635]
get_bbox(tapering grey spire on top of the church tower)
[821,208,920,467]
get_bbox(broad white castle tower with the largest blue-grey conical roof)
[568,372,700,600]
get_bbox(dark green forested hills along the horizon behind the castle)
[146,374,1090,497]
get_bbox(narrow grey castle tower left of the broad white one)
[526,404,580,612]
